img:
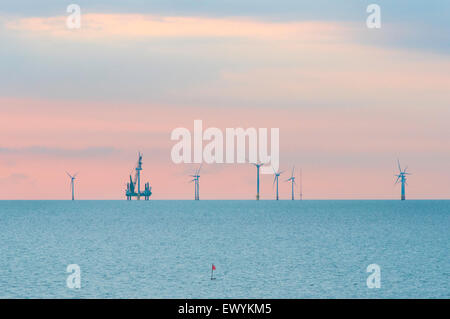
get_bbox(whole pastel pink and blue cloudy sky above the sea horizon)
[0,0,450,199]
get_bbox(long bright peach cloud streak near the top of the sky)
[5,13,349,42]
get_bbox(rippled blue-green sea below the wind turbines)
[0,200,450,298]
